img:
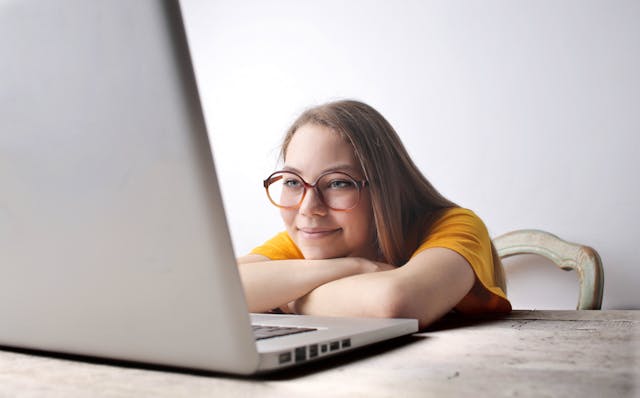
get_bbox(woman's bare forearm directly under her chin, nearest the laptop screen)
[238,254,392,312]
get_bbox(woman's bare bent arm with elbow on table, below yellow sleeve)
[294,248,475,328]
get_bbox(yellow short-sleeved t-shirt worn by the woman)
[251,207,511,314]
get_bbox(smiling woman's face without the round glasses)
[280,123,376,259]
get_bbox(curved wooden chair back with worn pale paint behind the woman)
[493,229,604,310]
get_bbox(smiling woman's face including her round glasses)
[269,123,376,259]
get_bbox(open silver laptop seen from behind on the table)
[0,0,418,375]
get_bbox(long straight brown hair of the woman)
[281,100,503,290]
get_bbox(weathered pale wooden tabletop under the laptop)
[0,311,640,397]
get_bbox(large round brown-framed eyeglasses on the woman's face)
[263,171,368,211]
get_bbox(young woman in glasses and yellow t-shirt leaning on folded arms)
[238,101,511,327]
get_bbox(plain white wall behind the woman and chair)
[183,0,640,308]
